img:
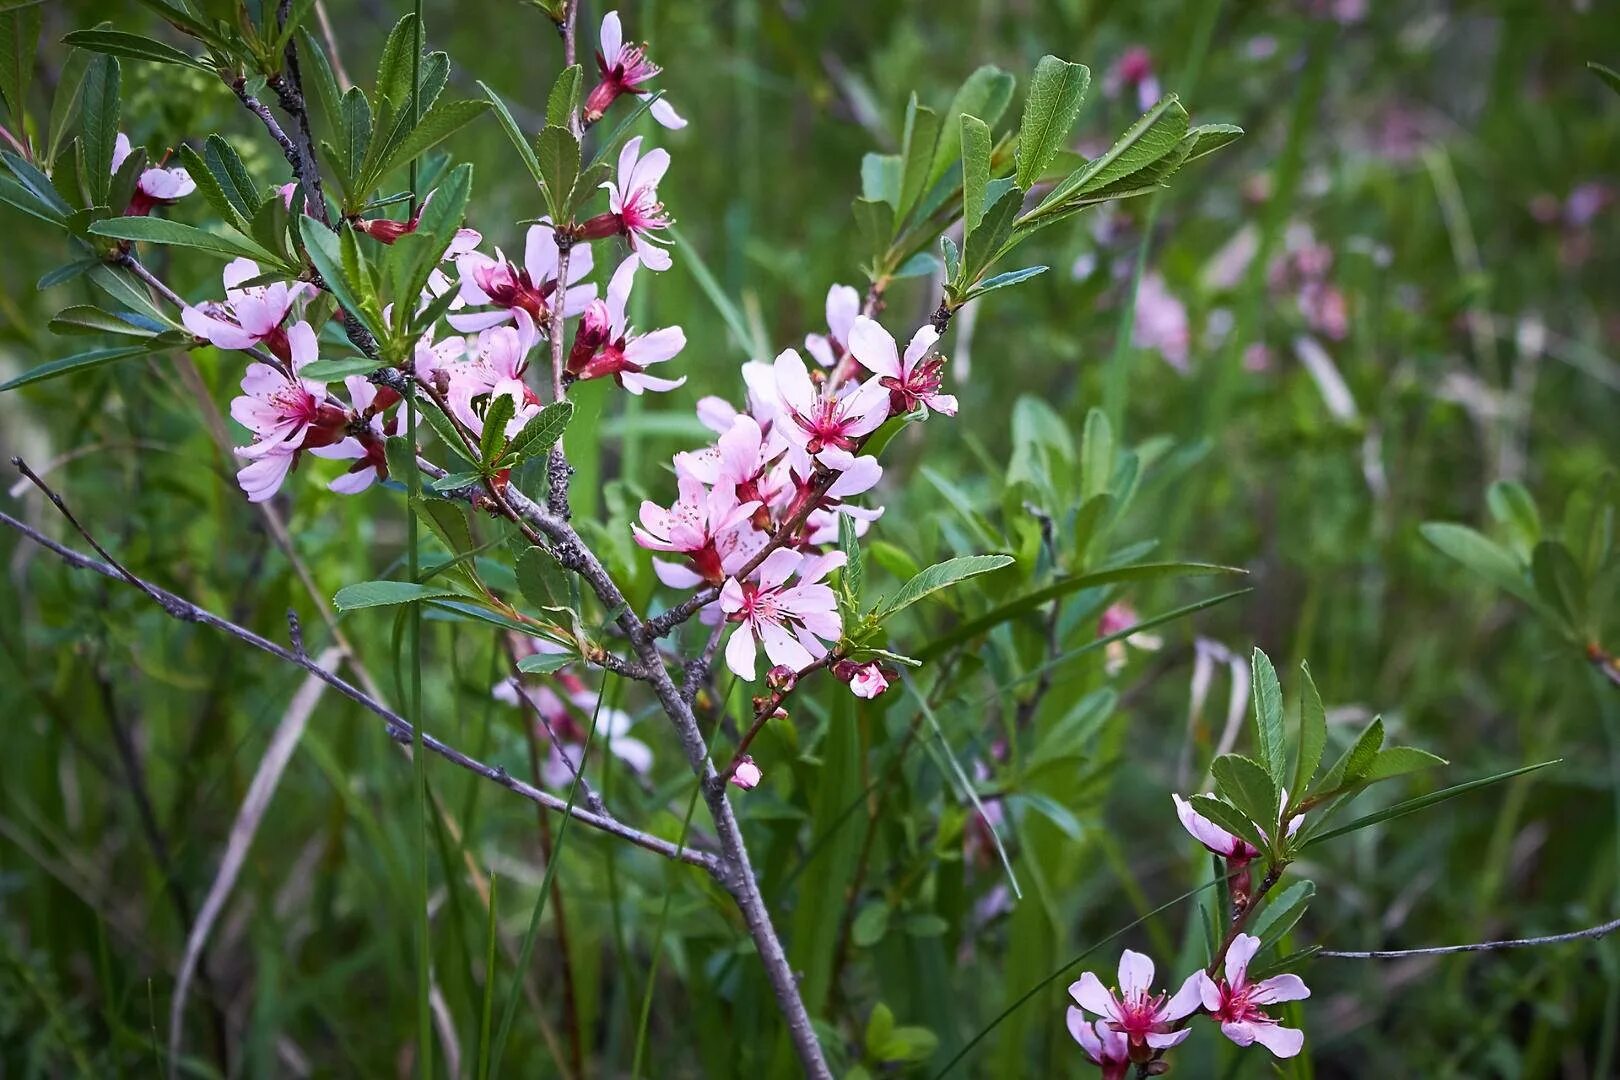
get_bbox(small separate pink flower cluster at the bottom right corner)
[1068,793,1311,1080]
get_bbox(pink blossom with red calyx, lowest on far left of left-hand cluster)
[230,322,348,502]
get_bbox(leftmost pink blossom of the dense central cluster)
[630,476,765,589]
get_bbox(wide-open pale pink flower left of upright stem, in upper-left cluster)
[446,222,596,334]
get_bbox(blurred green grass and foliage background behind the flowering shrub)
[0,0,1620,1077]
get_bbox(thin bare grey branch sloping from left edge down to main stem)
[0,487,718,873]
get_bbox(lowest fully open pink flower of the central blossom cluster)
[719,549,844,682]
